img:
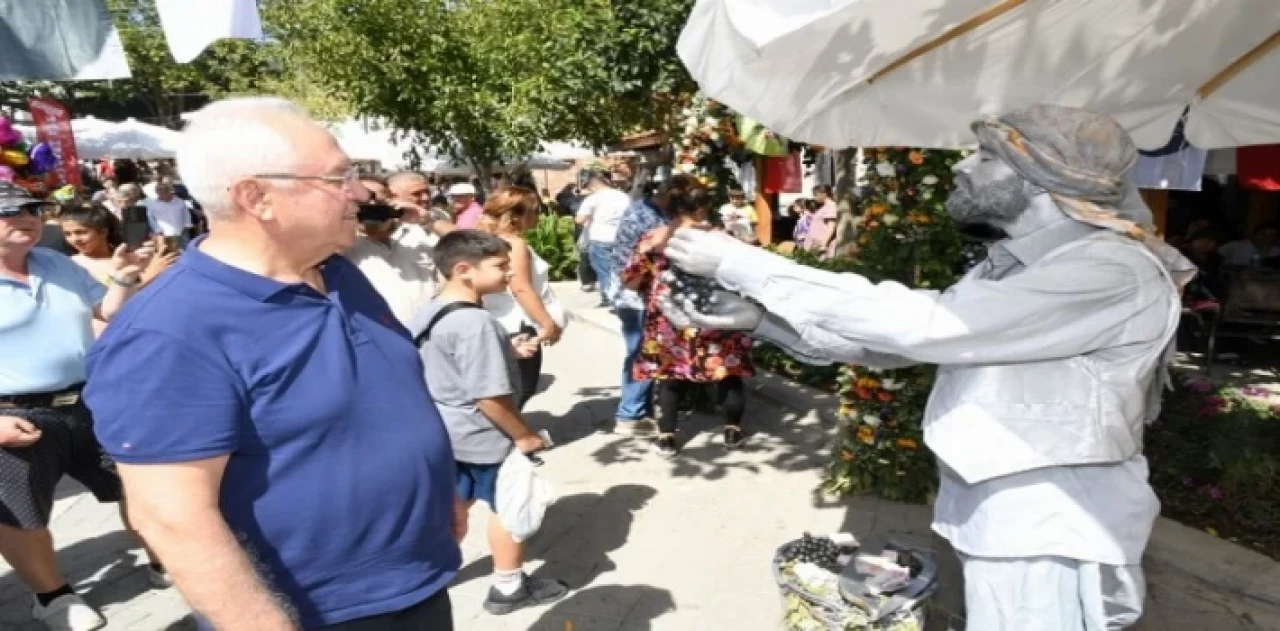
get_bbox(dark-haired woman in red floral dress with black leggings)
[621,191,753,458]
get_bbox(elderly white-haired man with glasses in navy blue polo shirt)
[84,99,466,631]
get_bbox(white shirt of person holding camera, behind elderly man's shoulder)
[343,224,439,326]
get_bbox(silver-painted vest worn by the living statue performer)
[924,233,1181,484]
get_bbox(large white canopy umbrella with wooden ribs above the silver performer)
[677,0,1280,150]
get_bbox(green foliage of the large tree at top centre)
[264,0,692,172]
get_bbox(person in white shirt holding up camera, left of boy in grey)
[343,173,453,324]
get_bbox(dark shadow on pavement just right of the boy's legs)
[451,484,658,589]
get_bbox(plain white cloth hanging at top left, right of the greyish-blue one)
[155,0,262,64]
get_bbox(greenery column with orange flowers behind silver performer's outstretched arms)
[824,147,963,503]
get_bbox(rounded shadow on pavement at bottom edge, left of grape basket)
[529,585,676,631]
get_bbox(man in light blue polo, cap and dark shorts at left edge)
[0,182,163,631]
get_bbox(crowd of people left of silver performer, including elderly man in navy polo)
[0,93,751,631]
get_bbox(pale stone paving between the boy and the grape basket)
[0,287,1280,631]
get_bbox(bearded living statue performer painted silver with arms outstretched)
[663,105,1194,631]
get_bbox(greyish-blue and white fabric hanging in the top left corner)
[0,0,131,81]
